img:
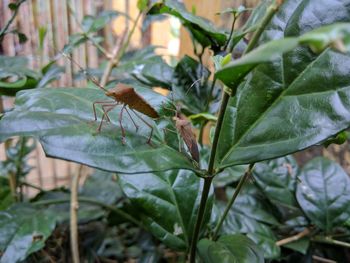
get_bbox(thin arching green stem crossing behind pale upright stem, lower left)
[33,197,144,228]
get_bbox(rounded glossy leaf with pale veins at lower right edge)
[297,157,350,233]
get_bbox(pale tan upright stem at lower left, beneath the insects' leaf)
[70,172,82,263]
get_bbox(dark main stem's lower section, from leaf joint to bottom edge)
[190,177,213,263]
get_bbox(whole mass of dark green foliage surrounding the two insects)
[0,0,350,263]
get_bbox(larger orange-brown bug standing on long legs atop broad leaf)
[61,53,159,144]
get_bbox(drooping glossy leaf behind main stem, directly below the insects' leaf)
[119,170,212,250]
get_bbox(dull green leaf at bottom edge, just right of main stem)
[198,235,264,263]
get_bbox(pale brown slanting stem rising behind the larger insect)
[101,11,142,86]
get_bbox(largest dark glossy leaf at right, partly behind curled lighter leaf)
[216,0,350,169]
